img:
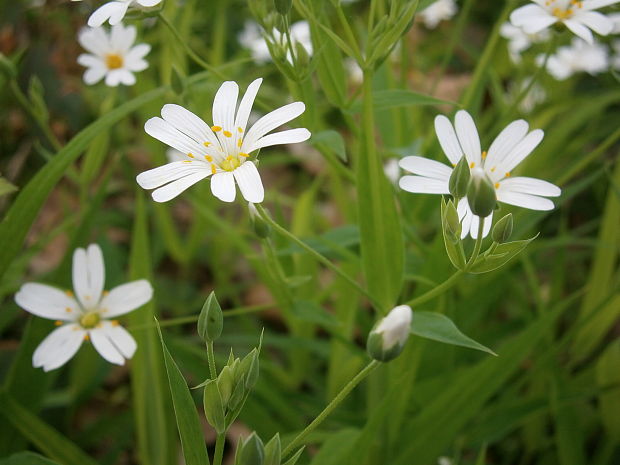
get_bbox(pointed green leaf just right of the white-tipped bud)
[411,312,497,355]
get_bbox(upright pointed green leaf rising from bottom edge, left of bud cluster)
[155,320,209,465]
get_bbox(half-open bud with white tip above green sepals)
[366,305,412,362]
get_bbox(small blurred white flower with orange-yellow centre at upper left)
[78,24,151,87]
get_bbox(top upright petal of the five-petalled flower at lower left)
[72,244,105,309]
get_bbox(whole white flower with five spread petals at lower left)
[15,244,153,371]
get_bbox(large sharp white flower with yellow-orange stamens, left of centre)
[136,79,310,203]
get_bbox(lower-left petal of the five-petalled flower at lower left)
[32,324,86,371]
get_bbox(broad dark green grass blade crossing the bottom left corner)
[0,392,97,465]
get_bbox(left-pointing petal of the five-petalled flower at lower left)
[15,283,80,321]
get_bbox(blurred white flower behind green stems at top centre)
[238,21,313,65]
